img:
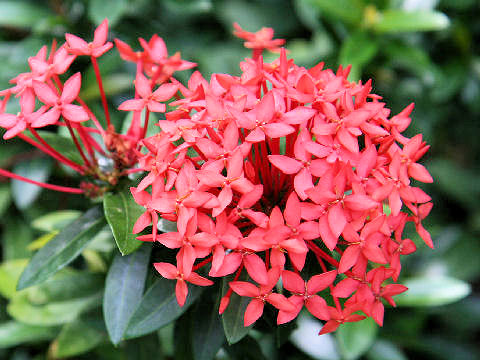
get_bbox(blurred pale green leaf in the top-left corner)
[0,0,51,29]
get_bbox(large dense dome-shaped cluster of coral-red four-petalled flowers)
[129,26,433,333]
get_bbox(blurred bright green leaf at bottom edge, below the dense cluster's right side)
[336,318,378,360]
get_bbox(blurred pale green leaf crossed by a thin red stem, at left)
[12,158,52,210]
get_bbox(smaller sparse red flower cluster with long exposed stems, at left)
[0,19,195,197]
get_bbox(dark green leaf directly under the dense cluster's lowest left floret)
[125,278,202,339]
